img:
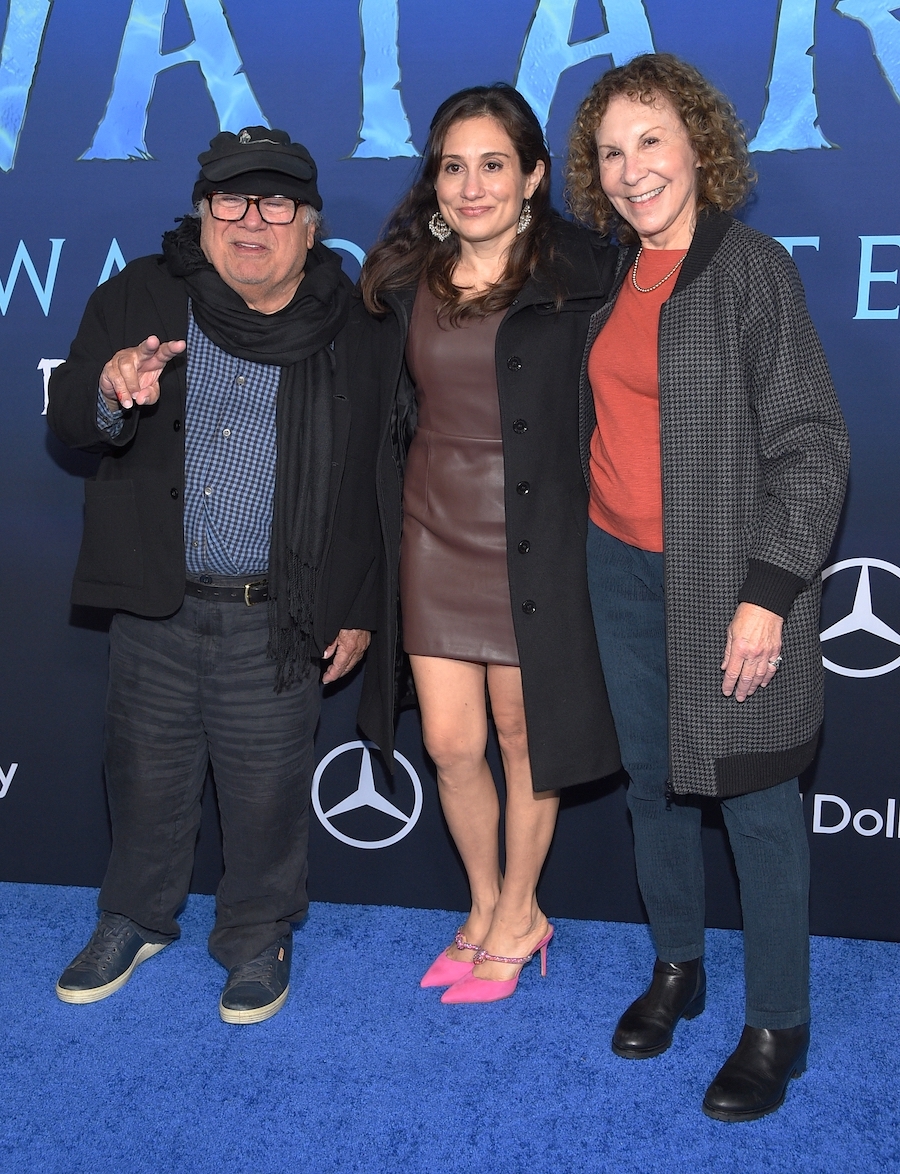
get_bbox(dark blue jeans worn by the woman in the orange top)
[588,522,810,1028]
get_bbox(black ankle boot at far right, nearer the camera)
[703,1024,810,1121]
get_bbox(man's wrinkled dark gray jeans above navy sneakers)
[100,598,320,967]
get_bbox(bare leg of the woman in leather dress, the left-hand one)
[410,656,502,970]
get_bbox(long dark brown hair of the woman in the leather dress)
[360,82,553,323]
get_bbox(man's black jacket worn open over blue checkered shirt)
[47,256,383,652]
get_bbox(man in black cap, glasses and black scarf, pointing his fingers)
[48,127,381,1023]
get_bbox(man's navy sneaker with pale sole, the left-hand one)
[56,913,169,1003]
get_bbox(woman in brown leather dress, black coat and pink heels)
[361,85,618,1003]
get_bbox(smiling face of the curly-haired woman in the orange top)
[595,94,699,249]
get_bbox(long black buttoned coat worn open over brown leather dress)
[360,221,620,791]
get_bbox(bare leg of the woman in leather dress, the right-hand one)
[475,664,560,979]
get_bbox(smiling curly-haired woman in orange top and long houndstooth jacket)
[568,53,848,1121]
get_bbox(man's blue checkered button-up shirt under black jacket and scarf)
[97,315,282,575]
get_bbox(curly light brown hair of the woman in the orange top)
[566,53,756,244]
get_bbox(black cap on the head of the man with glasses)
[192,127,322,210]
